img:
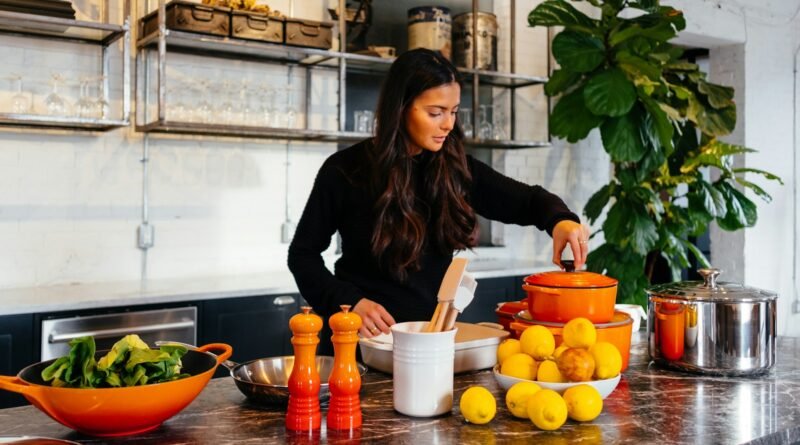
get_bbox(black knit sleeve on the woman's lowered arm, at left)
[288,158,363,316]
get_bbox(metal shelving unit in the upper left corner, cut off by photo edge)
[0,4,131,131]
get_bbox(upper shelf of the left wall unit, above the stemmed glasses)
[0,11,128,46]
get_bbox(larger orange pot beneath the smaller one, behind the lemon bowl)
[511,311,633,371]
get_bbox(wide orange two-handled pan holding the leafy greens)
[0,343,233,437]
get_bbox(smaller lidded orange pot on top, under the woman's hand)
[522,271,617,323]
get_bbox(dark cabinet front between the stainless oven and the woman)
[199,294,300,376]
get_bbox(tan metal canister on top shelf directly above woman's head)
[408,6,452,60]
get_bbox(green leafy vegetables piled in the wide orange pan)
[42,335,189,388]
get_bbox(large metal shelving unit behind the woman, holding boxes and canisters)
[136,0,550,149]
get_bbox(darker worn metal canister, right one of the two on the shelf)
[453,12,497,70]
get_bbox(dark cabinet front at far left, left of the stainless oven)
[0,314,34,408]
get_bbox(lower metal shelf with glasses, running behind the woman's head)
[136,120,550,150]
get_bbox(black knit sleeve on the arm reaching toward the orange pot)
[467,156,580,236]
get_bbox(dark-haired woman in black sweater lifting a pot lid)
[289,49,588,350]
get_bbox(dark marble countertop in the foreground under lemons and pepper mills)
[0,334,800,445]
